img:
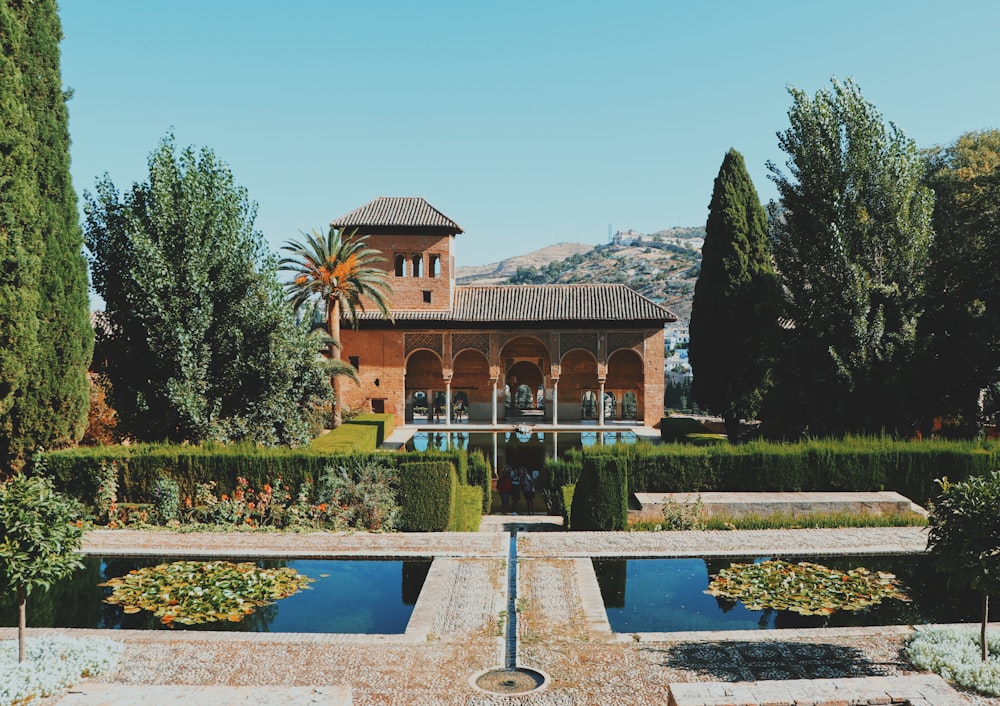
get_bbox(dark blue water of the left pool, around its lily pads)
[0,557,431,634]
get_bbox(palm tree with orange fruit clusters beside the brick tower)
[278,228,393,429]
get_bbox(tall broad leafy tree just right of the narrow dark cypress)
[768,80,933,434]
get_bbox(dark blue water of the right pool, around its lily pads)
[594,556,981,633]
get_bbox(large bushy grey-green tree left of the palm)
[84,136,329,445]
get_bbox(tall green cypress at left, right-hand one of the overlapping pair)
[10,0,94,454]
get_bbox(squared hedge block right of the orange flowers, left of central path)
[399,460,458,532]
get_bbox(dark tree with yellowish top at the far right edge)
[920,130,1000,436]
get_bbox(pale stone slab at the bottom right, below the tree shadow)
[667,674,968,706]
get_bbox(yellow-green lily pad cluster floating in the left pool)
[100,561,313,625]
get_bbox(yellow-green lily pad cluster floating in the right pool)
[705,560,910,615]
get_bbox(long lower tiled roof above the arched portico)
[358,284,677,325]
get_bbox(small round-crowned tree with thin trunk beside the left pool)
[0,474,83,662]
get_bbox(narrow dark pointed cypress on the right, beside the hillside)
[689,149,778,442]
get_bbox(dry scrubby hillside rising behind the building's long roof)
[456,228,705,321]
